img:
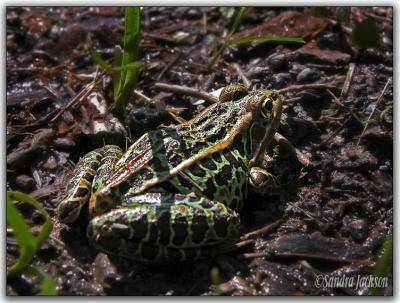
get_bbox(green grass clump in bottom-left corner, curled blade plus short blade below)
[6,191,57,295]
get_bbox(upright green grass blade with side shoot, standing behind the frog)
[91,7,143,118]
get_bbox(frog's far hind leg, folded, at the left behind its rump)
[57,145,123,223]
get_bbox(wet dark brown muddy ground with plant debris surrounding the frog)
[6,7,393,296]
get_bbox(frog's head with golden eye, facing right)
[220,85,282,167]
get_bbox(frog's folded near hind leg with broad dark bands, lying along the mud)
[88,193,240,262]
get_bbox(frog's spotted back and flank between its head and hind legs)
[101,102,246,202]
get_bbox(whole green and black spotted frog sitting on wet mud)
[58,85,282,262]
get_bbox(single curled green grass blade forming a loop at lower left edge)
[6,191,53,277]
